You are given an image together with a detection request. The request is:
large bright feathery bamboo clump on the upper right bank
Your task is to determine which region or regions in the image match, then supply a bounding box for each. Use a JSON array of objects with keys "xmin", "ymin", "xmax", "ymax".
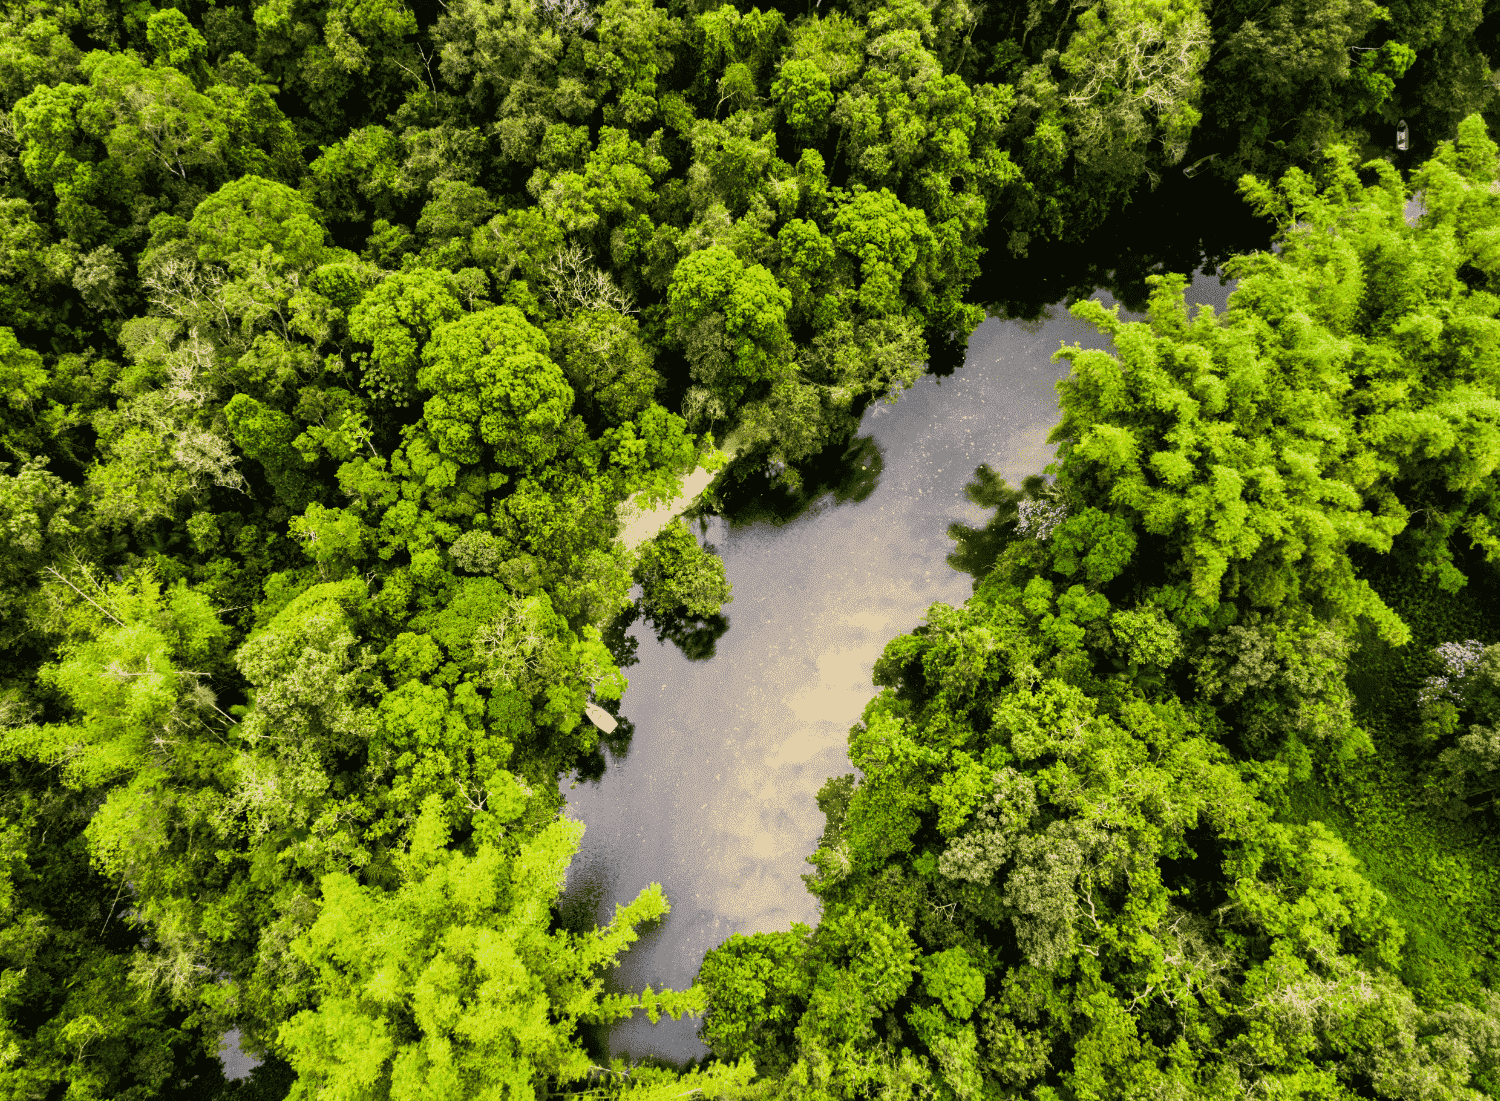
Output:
[{"xmin": 1056, "ymin": 122, "xmax": 1500, "ymax": 641}]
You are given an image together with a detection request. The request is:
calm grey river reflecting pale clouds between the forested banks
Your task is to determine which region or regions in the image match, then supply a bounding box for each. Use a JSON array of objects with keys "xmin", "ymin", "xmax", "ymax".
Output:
[{"xmin": 563, "ymin": 276, "xmax": 1230, "ymax": 1061}]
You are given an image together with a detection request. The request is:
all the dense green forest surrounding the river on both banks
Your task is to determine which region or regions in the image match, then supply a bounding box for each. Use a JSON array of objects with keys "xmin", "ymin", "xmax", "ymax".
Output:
[{"xmin": 0, "ymin": 0, "xmax": 1500, "ymax": 1101}]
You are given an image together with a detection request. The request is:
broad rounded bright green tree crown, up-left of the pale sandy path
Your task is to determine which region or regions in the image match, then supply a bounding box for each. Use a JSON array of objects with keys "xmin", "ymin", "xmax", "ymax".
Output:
[{"xmin": 417, "ymin": 306, "xmax": 573, "ymax": 468}]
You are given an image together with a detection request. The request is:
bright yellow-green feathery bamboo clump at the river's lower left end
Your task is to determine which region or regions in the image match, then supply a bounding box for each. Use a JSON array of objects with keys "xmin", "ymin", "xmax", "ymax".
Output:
[{"xmin": 281, "ymin": 792, "xmax": 714, "ymax": 1101}]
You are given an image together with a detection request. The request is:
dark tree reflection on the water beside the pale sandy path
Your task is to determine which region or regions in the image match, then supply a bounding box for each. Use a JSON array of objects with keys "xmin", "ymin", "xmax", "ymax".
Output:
[{"xmin": 713, "ymin": 437, "xmax": 885, "ymax": 528}]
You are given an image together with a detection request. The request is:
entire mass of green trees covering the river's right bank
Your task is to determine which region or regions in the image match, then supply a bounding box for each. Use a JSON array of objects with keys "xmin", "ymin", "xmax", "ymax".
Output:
[{"xmin": 701, "ymin": 119, "xmax": 1500, "ymax": 1098}]
